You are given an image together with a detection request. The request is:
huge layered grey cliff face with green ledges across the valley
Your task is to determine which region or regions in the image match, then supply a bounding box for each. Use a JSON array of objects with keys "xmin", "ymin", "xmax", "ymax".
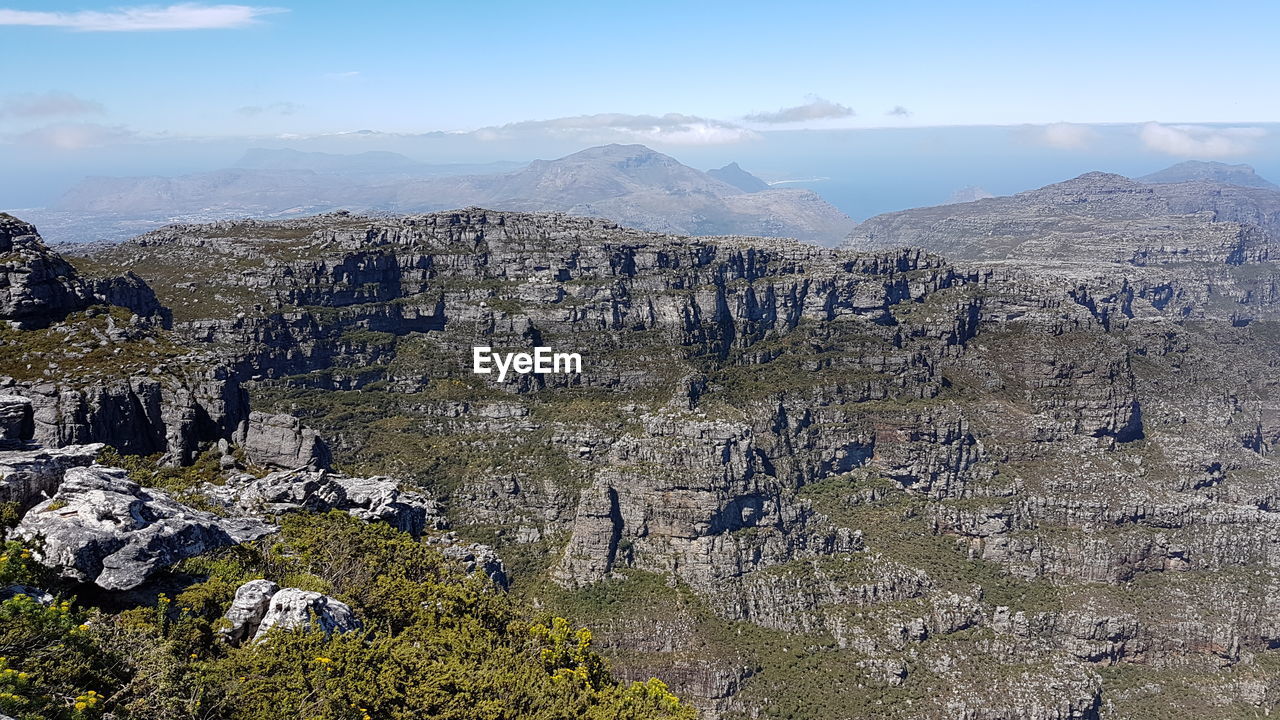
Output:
[{"xmin": 52, "ymin": 206, "xmax": 1280, "ymax": 719}]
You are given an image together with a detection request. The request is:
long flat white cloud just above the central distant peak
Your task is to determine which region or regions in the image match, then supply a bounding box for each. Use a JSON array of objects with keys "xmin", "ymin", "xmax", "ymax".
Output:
[{"xmin": 474, "ymin": 113, "xmax": 759, "ymax": 145}]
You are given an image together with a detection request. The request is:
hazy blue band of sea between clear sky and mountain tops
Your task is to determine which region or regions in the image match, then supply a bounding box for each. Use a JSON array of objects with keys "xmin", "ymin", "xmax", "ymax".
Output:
[{"xmin": 0, "ymin": 124, "xmax": 1280, "ymax": 220}]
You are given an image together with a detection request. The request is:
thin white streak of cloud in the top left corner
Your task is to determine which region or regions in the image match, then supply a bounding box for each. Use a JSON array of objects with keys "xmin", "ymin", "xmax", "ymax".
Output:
[{"xmin": 0, "ymin": 3, "xmax": 287, "ymax": 32}]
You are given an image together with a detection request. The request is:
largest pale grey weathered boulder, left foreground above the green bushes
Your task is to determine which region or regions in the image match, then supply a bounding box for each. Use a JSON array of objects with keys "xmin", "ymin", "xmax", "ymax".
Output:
[{"xmin": 13, "ymin": 465, "xmax": 275, "ymax": 591}]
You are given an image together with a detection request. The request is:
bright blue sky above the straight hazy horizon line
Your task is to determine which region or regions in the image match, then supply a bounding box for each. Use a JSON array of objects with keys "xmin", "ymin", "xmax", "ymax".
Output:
[{"xmin": 0, "ymin": 0, "xmax": 1280, "ymax": 136}]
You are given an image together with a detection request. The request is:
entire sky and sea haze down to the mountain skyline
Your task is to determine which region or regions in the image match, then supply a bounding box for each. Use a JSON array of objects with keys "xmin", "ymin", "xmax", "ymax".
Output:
[{"xmin": 0, "ymin": 3, "xmax": 1280, "ymax": 219}]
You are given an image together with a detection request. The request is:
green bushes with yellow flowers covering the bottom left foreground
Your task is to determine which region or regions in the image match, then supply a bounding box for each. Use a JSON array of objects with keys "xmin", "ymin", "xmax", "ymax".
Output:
[{"xmin": 0, "ymin": 512, "xmax": 694, "ymax": 720}]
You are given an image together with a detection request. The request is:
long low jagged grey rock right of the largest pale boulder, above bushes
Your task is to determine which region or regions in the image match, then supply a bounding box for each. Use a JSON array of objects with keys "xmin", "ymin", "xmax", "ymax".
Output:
[{"xmin": 201, "ymin": 469, "xmax": 445, "ymax": 534}]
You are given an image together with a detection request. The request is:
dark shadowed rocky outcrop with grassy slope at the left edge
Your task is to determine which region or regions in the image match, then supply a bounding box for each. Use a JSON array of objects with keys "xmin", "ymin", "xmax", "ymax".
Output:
[{"xmin": 0, "ymin": 215, "xmax": 247, "ymax": 462}]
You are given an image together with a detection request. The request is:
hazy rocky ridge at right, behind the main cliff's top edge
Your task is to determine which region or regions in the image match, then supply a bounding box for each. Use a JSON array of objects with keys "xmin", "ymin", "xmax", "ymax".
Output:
[{"xmin": 846, "ymin": 163, "xmax": 1280, "ymax": 265}]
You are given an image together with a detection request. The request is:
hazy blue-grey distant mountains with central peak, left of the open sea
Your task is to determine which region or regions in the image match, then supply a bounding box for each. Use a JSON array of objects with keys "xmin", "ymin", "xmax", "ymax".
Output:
[{"xmin": 49, "ymin": 145, "xmax": 854, "ymax": 245}]
